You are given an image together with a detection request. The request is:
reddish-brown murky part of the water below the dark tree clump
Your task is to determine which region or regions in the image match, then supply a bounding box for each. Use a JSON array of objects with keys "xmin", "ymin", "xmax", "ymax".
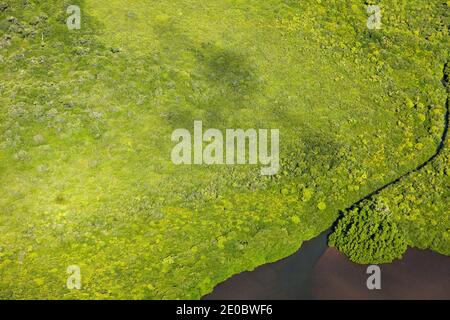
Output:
[{"xmin": 311, "ymin": 248, "xmax": 450, "ymax": 300}]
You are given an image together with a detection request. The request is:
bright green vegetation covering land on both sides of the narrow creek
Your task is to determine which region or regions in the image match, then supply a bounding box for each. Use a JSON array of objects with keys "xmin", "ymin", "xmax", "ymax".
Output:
[{"xmin": 0, "ymin": 0, "xmax": 450, "ymax": 299}]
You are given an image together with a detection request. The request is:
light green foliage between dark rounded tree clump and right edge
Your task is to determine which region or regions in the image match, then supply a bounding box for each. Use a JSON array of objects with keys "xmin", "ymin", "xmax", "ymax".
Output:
[{"xmin": 379, "ymin": 133, "xmax": 450, "ymax": 255}]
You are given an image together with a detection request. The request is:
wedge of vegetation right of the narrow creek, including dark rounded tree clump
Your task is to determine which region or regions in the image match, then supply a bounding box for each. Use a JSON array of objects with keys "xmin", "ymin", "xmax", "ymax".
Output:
[{"xmin": 329, "ymin": 64, "xmax": 450, "ymax": 264}]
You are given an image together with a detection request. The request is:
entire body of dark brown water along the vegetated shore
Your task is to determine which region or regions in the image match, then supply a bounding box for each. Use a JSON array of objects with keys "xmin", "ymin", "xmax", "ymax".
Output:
[{"xmin": 203, "ymin": 230, "xmax": 450, "ymax": 300}]
